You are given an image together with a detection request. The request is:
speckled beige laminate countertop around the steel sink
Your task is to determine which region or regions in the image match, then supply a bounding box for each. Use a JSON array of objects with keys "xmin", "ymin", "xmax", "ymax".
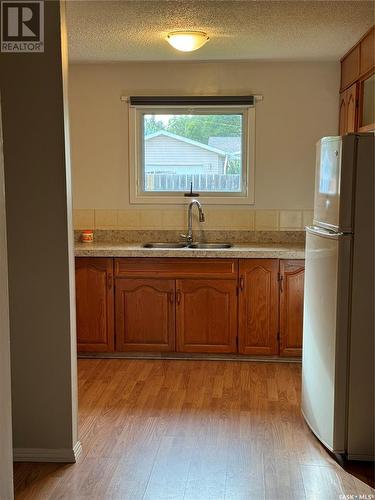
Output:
[{"xmin": 75, "ymin": 242, "xmax": 305, "ymax": 259}]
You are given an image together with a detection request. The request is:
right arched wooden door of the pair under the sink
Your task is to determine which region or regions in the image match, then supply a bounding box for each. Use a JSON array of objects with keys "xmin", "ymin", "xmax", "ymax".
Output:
[{"xmin": 176, "ymin": 279, "xmax": 237, "ymax": 353}]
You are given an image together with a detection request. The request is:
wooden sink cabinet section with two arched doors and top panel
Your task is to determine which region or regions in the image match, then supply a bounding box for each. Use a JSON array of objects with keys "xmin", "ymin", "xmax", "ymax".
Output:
[{"xmin": 115, "ymin": 258, "xmax": 238, "ymax": 353}]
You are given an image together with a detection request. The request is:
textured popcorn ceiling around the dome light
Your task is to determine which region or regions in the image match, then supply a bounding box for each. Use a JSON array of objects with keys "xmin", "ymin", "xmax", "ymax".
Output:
[{"xmin": 67, "ymin": 0, "xmax": 374, "ymax": 62}]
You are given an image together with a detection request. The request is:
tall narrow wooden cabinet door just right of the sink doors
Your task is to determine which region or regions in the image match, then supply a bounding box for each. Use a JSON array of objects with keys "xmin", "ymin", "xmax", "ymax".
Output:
[{"xmin": 238, "ymin": 259, "xmax": 279, "ymax": 356}]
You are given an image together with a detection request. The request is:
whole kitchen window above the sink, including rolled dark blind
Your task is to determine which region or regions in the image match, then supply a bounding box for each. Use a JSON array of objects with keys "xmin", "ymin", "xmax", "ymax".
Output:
[{"xmin": 129, "ymin": 96, "xmax": 255, "ymax": 204}]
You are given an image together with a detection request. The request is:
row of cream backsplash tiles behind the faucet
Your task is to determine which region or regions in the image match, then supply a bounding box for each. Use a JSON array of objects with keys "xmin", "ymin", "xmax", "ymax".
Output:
[{"xmin": 73, "ymin": 206, "xmax": 313, "ymax": 231}]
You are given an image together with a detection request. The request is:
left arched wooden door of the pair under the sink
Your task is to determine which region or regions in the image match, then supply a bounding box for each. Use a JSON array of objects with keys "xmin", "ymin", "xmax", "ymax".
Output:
[{"xmin": 115, "ymin": 278, "xmax": 175, "ymax": 352}]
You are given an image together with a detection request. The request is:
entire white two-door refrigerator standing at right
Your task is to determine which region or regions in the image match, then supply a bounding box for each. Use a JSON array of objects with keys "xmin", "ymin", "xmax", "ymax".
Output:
[{"xmin": 302, "ymin": 133, "xmax": 375, "ymax": 460}]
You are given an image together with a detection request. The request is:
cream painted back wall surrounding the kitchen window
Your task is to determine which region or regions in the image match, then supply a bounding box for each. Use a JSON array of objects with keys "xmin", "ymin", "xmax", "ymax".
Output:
[{"xmin": 69, "ymin": 62, "xmax": 339, "ymax": 230}]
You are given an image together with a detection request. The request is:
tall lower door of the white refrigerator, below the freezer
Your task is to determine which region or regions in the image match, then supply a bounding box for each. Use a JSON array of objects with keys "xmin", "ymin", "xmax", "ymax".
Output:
[{"xmin": 302, "ymin": 227, "xmax": 351, "ymax": 453}]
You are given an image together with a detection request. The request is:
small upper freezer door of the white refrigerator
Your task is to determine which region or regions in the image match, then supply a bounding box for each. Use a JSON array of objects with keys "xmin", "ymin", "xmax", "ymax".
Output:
[{"xmin": 314, "ymin": 137, "xmax": 342, "ymax": 229}]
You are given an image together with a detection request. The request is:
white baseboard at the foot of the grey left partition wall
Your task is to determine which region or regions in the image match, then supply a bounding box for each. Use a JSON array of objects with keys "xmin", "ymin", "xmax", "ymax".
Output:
[{"xmin": 13, "ymin": 441, "xmax": 82, "ymax": 463}]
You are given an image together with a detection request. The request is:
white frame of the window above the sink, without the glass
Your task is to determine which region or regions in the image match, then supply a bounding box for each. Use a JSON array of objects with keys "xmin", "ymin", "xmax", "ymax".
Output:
[{"xmin": 128, "ymin": 105, "xmax": 255, "ymax": 205}]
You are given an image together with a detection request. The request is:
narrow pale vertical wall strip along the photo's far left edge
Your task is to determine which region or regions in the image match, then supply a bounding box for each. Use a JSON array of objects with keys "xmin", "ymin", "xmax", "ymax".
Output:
[{"xmin": 0, "ymin": 97, "xmax": 13, "ymax": 500}]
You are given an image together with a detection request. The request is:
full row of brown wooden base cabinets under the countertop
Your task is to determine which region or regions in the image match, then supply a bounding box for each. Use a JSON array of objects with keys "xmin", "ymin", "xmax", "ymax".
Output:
[{"xmin": 76, "ymin": 257, "xmax": 304, "ymax": 357}]
